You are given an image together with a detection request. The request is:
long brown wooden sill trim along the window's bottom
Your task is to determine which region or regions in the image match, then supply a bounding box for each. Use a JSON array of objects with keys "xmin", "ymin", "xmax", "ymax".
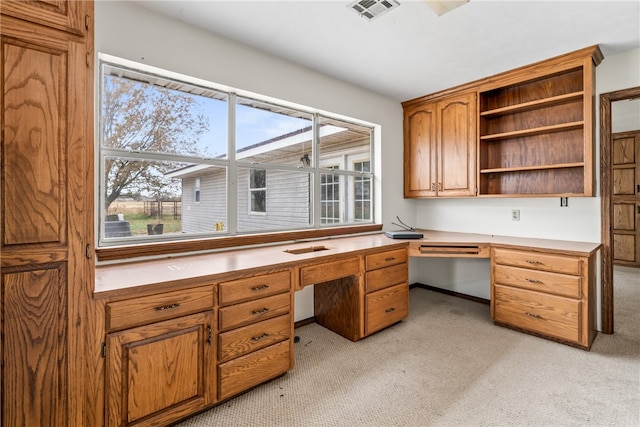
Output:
[{"xmin": 96, "ymin": 224, "xmax": 382, "ymax": 261}]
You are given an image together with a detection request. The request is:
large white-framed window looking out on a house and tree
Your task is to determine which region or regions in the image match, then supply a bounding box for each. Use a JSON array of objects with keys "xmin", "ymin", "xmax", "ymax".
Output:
[{"xmin": 97, "ymin": 55, "xmax": 373, "ymax": 251}]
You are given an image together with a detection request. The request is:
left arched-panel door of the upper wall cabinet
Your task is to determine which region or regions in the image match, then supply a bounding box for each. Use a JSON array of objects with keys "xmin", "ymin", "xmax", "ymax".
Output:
[{"xmin": 404, "ymin": 103, "xmax": 437, "ymax": 198}]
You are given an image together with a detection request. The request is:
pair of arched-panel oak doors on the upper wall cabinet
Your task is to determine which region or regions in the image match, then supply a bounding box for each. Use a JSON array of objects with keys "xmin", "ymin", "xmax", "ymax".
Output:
[{"xmin": 403, "ymin": 92, "xmax": 477, "ymax": 198}]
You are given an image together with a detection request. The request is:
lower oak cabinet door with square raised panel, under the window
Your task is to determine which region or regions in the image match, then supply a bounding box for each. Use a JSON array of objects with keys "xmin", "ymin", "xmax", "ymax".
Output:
[{"xmin": 106, "ymin": 311, "xmax": 216, "ymax": 426}]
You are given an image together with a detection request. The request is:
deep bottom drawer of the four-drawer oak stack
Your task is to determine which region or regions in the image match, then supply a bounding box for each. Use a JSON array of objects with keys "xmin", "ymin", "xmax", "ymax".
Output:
[{"xmin": 218, "ymin": 340, "xmax": 291, "ymax": 400}]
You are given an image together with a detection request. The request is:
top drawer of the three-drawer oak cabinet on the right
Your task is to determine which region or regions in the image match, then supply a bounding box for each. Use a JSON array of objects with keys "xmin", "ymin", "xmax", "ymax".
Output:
[{"xmin": 493, "ymin": 249, "xmax": 582, "ymax": 276}]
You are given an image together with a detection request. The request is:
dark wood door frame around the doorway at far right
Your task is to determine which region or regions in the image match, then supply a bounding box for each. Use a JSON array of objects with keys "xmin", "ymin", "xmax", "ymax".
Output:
[{"xmin": 600, "ymin": 86, "xmax": 640, "ymax": 334}]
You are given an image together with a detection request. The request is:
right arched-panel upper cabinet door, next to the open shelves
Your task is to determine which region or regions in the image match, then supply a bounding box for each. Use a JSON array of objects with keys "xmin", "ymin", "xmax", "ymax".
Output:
[{"xmin": 437, "ymin": 92, "xmax": 477, "ymax": 197}]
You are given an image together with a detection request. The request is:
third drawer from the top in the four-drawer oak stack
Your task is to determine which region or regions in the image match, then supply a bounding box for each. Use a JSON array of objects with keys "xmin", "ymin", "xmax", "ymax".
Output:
[{"xmin": 218, "ymin": 314, "xmax": 292, "ymax": 362}]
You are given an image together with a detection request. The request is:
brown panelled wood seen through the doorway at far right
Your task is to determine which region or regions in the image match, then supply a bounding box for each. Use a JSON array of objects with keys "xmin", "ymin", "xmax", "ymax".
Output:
[{"xmin": 611, "ymin": 131, "xmax": 640, "ymax": 267}]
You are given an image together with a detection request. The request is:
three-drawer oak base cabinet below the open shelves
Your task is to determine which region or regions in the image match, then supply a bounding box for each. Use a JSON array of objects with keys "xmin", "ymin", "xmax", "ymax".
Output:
[{"xmin": 491, "ymin": 248, "xmax": 595, "ymax": 349}]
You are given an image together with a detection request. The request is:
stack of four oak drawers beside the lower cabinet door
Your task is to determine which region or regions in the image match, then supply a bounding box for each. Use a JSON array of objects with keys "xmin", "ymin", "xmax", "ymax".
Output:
[{"xmin": 217, "ymin": 270, "xmax": 293, "ymax": 400}]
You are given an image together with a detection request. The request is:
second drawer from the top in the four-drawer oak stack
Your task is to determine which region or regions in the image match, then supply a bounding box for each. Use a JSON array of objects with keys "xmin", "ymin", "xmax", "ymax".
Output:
[{"xmin": 218, "ymin": 292, "xmax": 291, "ymax": 331}]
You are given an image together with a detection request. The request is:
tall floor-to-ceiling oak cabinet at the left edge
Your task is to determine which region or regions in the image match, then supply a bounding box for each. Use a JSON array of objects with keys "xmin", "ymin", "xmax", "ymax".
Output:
[{"xmin": 0, "ymin": 0, "xmax": 93, "ymax": 426}]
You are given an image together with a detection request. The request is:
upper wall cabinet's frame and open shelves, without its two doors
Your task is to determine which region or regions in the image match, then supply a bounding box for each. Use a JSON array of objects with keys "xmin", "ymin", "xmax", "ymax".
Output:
[{"xmin": 403, "ymin": 46, "xmax": 603, "ymax": 197}]
